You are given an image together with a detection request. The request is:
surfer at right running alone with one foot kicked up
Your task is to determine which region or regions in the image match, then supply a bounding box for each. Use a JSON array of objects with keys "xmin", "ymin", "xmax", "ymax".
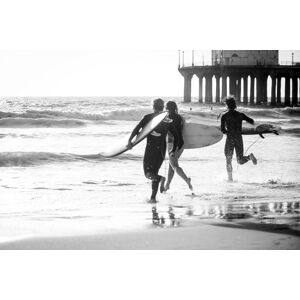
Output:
[{"xmin": 221, "ymin": 96, "xmax": 257, "ymax": 181}]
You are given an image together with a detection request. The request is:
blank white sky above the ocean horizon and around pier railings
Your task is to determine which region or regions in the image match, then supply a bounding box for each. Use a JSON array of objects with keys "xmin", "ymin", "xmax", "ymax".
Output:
[{"xmin": 0, "ymin": 49, "xmax": 300, "ymax": 96}]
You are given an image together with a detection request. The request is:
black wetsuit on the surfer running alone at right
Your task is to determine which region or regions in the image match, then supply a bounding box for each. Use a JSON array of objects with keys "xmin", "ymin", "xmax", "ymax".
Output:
[{"xmin": 221, "ymin": 110, "xmax": 254, "ymax": 166}]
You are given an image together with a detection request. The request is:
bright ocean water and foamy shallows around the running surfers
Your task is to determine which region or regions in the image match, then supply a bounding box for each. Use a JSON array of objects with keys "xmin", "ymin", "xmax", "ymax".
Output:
[{"xmin": 0, "ymin": 97, "xmax": 300, "ymax": 243}]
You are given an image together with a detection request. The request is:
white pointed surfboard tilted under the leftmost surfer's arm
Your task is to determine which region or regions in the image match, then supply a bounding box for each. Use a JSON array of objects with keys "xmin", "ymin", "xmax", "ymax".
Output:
[{"xmin": 100, "ymin": 112, "xmax": 168, "ymax": 157}]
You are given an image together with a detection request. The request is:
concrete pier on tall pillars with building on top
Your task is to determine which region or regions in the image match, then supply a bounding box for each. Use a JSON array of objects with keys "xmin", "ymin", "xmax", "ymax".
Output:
[{"xmin": 178, "ymin": 50, "xmax": 300, "ymax": 106}]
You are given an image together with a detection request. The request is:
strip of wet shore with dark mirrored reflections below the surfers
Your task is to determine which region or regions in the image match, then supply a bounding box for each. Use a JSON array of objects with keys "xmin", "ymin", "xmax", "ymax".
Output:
[{"xmin": 152, "ymin": 201, "xmax": 300, "ymax": 227}]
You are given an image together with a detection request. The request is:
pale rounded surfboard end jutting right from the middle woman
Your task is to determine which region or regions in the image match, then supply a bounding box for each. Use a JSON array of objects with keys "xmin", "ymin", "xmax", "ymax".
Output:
[{"xmin": 182, "ymin": 123, "xmax": 223, "ymax": 149}]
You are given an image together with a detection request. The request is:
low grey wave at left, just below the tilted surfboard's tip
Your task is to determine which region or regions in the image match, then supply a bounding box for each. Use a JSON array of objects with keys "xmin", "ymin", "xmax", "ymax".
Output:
[{"xmin": 0, "ymin": 152, "xmax": 141, "ymax": 167}]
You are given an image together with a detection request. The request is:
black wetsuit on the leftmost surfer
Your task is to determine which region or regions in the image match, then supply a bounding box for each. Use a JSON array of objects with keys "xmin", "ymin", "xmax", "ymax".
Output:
[{"xmin": 134, "ymin": 113, "xmax": 180, "ymax": 181}]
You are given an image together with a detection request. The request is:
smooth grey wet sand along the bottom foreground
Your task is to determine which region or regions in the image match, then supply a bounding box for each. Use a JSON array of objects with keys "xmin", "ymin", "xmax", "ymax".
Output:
[{"xmin": 0, "ymin": 220, "xmax": 300, "ymax": 250}]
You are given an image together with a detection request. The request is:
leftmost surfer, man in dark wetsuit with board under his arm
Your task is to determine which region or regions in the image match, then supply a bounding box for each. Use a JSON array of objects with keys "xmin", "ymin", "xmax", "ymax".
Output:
[{"xmin": 127, "ymin": 98, "xmax": 183, "ymax": 203}]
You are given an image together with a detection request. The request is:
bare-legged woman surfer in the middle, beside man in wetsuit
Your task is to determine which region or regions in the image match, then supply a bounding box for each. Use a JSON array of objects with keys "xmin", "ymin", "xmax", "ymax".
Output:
[{"xmin": 165, "ymin": 101, "xmax": 193, "ymax": 191}]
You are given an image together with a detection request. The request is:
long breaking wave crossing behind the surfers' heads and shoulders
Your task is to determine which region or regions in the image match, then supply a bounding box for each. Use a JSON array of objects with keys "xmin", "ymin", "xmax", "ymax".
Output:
[{"xmin": 0, "ymin": 104, "xmax": 300, "ymax": 127}]
